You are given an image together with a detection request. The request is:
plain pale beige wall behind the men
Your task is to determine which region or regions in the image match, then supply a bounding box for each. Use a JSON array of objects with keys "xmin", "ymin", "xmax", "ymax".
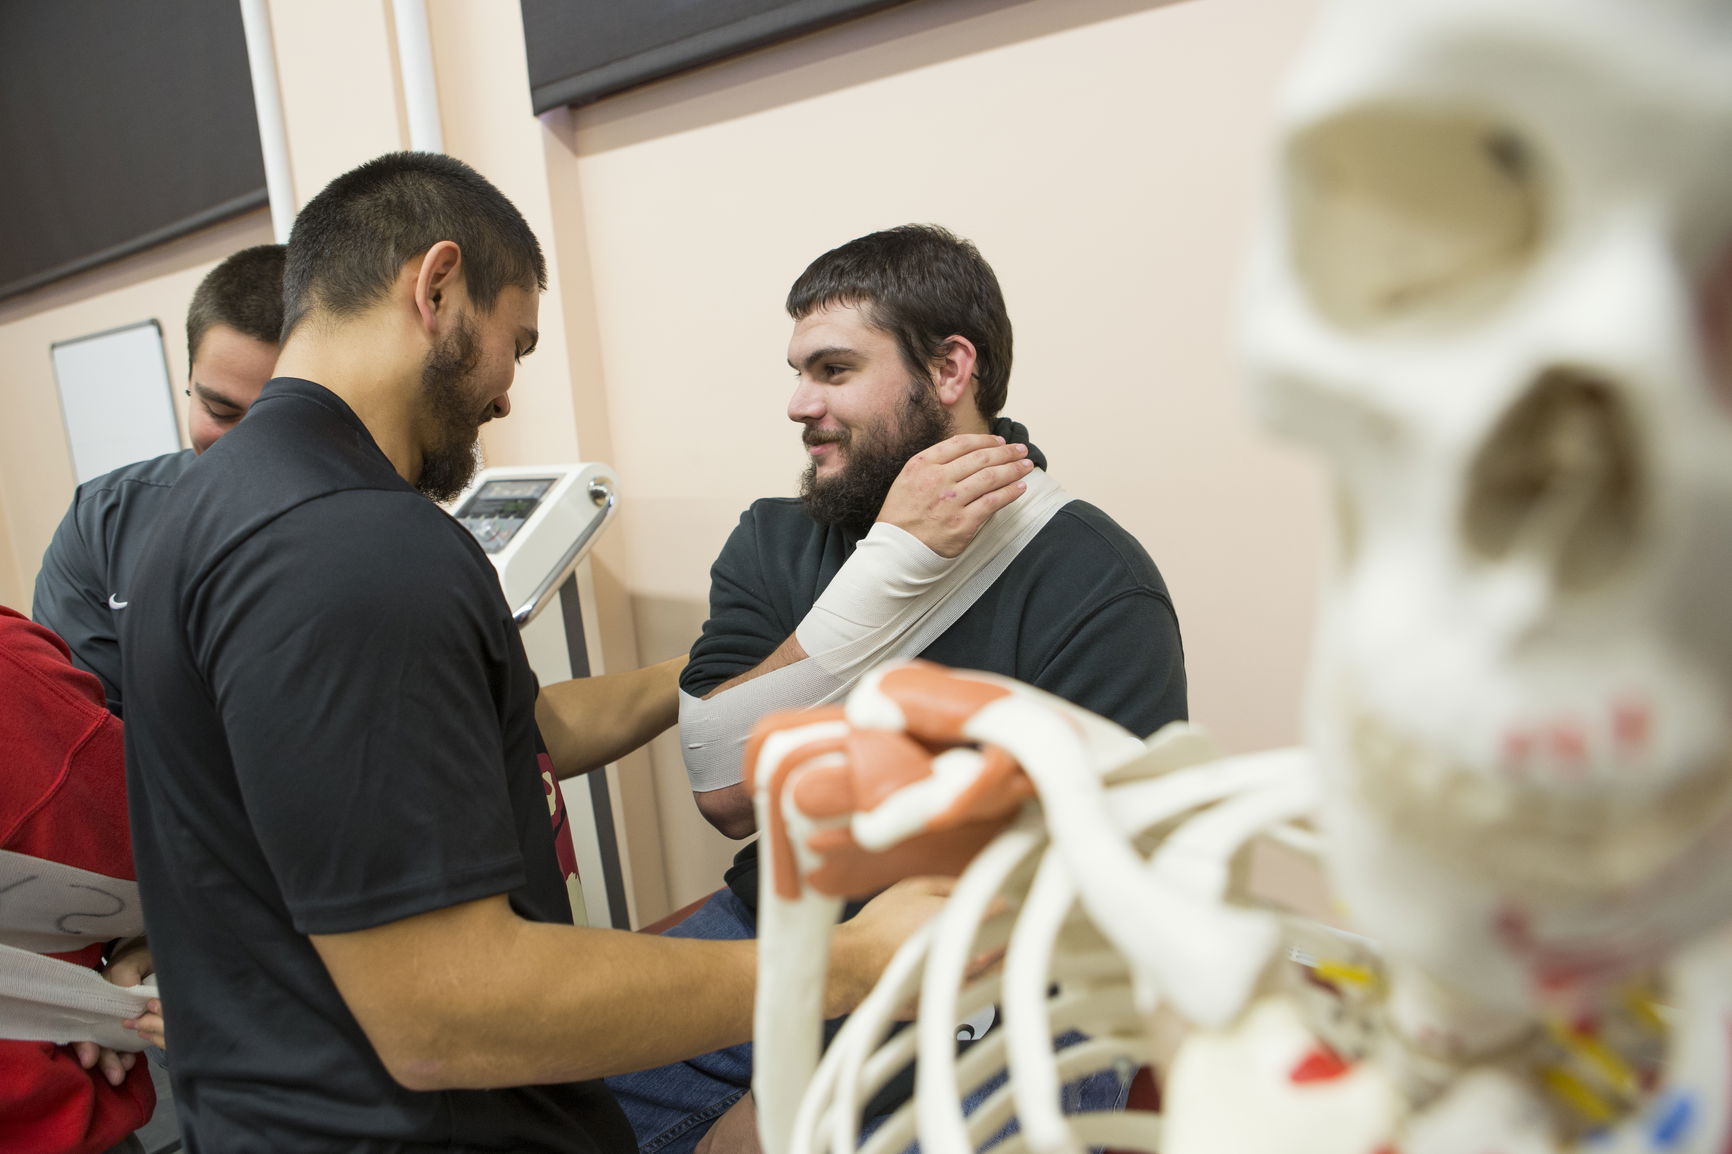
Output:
[{"xmin": 0, "ymin": 0, "xmax": 1322, "ymax": 918}]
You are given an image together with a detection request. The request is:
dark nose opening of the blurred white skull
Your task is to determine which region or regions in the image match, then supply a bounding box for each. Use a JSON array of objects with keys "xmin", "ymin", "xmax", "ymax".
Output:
[{"xmin": 1464, "ymin": 367, "xmax": 1642, "ymax": 591}]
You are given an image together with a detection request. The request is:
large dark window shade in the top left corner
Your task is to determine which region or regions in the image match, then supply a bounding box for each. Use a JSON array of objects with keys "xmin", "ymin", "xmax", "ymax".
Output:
[{"xmin": 0, "ymin": 0, "xmax": 265, "ymax": 300}]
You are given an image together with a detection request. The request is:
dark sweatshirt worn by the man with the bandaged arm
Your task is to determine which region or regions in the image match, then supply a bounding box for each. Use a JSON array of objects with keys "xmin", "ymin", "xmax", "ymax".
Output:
[{"xmin": 681, "ymin": 418, "xmax": 1186, "ymax": 908}]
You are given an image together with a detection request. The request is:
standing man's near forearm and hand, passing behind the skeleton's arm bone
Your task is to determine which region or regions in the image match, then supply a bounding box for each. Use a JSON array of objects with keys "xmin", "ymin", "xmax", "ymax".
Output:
[{"xmin": 312, "ymin": 884, "xmax": 940, "ymax": 1090}]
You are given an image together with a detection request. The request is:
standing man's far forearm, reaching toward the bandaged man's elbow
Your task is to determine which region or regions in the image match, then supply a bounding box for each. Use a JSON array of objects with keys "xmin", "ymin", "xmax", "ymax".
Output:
[{"xmin": 535, "ymin": 657, "xmax": 686, "ymax": 778}]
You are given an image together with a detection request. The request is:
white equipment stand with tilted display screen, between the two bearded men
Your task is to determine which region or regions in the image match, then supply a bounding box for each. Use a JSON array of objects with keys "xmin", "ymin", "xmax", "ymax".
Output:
[{"xmin": 450, "ymin": 463, "xmax": 630, "ymax": 929}]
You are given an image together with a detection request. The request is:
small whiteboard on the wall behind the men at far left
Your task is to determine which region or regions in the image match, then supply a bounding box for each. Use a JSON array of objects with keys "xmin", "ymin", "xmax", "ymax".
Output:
[{"xmin": 52, "ymin": 321, "xmax": 180, "ymax": 485}]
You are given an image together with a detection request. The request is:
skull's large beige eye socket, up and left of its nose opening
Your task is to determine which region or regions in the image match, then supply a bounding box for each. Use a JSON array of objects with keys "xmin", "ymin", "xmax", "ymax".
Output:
[{"xmin": 1287, "ymin": 109, "xmax": 1543, "ymax": 331}]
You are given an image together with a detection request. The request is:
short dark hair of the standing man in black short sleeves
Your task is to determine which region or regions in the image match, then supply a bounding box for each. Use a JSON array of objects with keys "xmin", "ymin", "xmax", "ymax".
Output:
[{"xmin": 282, "ymin": 152, "xmax": 547, "ymax": 336}]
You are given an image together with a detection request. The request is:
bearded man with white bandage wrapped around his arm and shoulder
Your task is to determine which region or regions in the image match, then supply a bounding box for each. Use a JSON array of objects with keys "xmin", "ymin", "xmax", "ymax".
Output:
[{"xmin": 608, "ymin": 225, "xmax": 1186, "ymax": 1154}]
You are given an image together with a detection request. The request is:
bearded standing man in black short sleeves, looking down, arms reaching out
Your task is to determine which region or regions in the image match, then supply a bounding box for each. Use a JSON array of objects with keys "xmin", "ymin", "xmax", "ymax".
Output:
[{"xmin": 121, "ymin": 152, "xmax": 939, "ymax": 1154}]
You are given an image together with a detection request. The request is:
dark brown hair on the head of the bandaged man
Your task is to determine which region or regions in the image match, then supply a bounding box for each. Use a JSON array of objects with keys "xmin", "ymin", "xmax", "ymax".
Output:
[{"xmin": 788, "ymin": 225, "xmax": 1011, "ymax": 421}]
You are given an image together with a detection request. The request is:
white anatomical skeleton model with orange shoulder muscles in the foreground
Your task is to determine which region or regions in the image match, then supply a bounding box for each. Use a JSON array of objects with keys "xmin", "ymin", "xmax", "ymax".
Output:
[{"xmin": 748, "ymin": 0, "xmax": 1732, "ymax": 1154}]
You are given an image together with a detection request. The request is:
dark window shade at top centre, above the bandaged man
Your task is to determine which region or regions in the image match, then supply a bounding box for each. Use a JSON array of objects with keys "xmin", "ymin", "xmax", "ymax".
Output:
[{"xmin": 521, "ymin": 0, "xmax": 908, "ymax": 114}]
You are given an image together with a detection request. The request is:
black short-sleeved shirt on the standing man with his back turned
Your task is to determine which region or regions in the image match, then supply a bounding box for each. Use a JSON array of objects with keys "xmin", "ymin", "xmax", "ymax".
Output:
[{"xmin": 120, "ymin": 378, "xmax": 634, "ymax": 1154}]
